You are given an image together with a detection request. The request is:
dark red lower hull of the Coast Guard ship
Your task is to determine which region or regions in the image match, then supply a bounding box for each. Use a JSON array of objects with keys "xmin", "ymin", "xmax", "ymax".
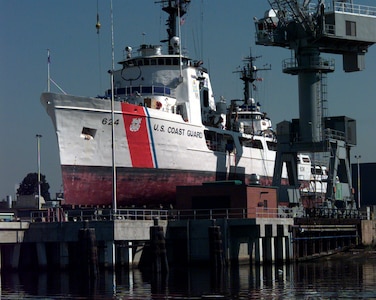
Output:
[{"xmin": 62, "ymin": 166, "xmax": 271, "ymax": 208}]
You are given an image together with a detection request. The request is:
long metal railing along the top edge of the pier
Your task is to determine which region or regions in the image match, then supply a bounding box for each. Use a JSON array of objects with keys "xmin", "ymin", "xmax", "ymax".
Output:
[{"xmin": 30, "ymin": 207, "xmax": 365, "ymax": 222}]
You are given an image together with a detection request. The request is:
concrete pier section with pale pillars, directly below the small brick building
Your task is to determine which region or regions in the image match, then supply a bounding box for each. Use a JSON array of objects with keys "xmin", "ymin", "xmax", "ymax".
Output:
[{"xmin": 166, "ymin": 218, "xmax": 293, "ymax": 264}]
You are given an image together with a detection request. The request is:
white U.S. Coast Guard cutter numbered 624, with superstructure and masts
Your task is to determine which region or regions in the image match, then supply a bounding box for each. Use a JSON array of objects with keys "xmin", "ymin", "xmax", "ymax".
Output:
[{"xmin": 41, "ymin": 0, "xmax": 310, "ymax": 207}]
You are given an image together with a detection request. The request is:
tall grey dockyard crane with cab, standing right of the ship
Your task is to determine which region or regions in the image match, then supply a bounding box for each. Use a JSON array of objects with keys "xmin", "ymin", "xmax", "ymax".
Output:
[{"xmin": 255, "ymin": 0, "xmax": 376, "ymax": 209}]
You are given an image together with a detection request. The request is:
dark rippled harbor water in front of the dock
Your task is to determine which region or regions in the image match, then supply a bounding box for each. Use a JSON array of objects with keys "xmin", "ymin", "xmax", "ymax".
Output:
[{"xmin": 1, "ymin": 252, "xmax": 376, "ymax": 299}]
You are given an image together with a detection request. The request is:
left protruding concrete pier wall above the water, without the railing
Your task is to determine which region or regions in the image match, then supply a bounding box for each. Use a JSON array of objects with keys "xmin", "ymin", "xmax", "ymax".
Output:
[{"xmin": 0, "ymin": 219, "xmax": 167, "ymax": 269}]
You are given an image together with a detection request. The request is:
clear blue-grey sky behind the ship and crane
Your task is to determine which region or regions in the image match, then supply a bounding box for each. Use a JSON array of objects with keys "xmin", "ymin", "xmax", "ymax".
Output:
[{"xmin": 0, "ymin": 0, "xmax": 376, "ymax": 200}]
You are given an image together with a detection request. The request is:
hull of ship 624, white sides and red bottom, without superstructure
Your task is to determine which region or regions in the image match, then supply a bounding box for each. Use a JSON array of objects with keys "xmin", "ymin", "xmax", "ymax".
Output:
[{"xmin": 41, "ymin": 93, "xmax": 275, "ymax": 206}]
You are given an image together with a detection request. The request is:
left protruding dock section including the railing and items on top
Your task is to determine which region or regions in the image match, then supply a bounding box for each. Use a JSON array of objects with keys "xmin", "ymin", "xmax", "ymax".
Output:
[{"xmin": 0, "ymin": 209, "xmax": 167, "ymax": 269}]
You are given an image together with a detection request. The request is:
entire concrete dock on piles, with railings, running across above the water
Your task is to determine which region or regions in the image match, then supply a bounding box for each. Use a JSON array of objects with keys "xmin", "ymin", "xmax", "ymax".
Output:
[{"xmin": 0, "ymin": 208, "xmax": 372, "ymax": 270}]
